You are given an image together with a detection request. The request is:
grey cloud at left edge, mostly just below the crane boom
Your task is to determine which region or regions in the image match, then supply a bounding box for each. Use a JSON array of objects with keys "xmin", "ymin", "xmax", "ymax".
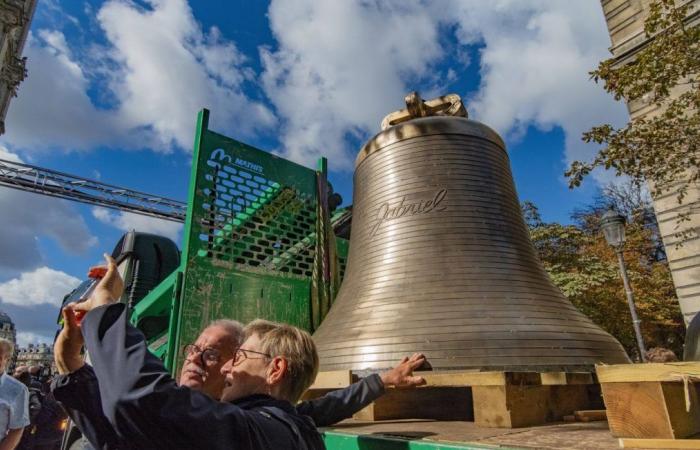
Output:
[{"xmin": 0, "ymin": 146, "xmax": 97, "ymax": 273}]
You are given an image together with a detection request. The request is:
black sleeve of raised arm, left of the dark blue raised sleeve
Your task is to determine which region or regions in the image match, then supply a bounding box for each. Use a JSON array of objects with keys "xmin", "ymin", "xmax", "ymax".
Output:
[{"xmin": 51, "ymin": 364, "xmax": 119, "ymax": 450}]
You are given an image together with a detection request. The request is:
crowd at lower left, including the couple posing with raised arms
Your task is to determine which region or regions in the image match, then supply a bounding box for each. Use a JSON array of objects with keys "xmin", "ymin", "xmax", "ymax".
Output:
[{"xmin": 0, "ymin": 255, "xmax": 426, "ymax": 450}]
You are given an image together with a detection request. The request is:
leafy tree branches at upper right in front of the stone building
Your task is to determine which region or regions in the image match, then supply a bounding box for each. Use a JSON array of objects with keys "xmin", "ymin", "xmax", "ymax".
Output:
[{"xmin": 566, "ymin": 0, "xmax": 700, "ymax": 213}]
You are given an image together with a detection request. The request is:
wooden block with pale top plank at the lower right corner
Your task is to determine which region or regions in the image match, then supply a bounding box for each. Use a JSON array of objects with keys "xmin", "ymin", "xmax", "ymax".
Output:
[{"xmin": 596, "ymin": 362, "xmax": 700, "ymax": 440}]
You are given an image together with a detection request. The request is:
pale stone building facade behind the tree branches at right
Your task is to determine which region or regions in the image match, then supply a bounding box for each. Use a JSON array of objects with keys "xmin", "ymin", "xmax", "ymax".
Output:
[{"xmin": 601, "ymin": 0, "xmax": 700, "ymax": 324}]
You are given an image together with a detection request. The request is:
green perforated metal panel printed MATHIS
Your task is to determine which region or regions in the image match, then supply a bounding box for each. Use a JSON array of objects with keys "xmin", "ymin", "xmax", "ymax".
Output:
[{"xmin": 169, "ymin": 110, "xmax": 318, "ymax": 370}]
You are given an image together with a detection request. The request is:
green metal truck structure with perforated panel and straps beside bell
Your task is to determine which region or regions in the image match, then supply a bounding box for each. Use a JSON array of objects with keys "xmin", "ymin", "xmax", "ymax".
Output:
[{"xmin": 131, "ymin": 110, "xmax": 348, "ymax": 373}]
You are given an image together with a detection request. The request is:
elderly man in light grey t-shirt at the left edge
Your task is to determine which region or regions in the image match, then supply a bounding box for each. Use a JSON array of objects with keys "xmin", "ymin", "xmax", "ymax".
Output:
[{"xmin": 0, "ymin": 338, "xmax": 29, "ymax": 450}]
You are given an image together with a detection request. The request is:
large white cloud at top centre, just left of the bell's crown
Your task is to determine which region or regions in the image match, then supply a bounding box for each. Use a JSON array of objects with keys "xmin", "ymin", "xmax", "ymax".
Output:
[{"xmin": 261, "ymin": 0, "xmax": 443, "ymax": 169}]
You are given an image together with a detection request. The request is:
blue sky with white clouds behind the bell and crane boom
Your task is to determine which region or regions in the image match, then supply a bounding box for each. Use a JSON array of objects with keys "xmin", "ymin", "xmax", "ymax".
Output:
[{"xmin": 0, "ymin": 0, "xmax": 626, "ymax": 344}]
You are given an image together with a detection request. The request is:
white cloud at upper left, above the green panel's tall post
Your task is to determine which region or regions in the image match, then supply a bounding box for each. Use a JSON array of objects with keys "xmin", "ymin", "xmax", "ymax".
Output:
[{"xmin": 98, "ymin": 0, "xmax": 274, "ymax": 149}]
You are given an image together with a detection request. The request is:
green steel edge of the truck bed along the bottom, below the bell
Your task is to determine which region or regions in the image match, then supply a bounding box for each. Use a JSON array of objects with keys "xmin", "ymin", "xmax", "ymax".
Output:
[{"xmin": 323, "ymin": 431, "xmax": 516, "ymax": 450}]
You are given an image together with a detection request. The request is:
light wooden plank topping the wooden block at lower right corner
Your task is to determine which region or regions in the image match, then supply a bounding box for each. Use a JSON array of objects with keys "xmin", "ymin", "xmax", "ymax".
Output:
[{"xmin": 595, "ymin": 362, "xmax": 700, "ymax": 383}]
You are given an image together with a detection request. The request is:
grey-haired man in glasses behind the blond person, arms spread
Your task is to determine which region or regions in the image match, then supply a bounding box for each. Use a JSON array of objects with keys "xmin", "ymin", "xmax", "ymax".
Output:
[{"xmin": 53, "ymin": 256, "xmax": 425, "ymax": 449}]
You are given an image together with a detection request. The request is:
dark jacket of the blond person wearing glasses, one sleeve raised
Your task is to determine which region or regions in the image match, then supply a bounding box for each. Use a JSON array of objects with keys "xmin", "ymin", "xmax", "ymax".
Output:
[{"xmin": 60, "ymin": 304, "xmax": 325, "ymax": 450}]
